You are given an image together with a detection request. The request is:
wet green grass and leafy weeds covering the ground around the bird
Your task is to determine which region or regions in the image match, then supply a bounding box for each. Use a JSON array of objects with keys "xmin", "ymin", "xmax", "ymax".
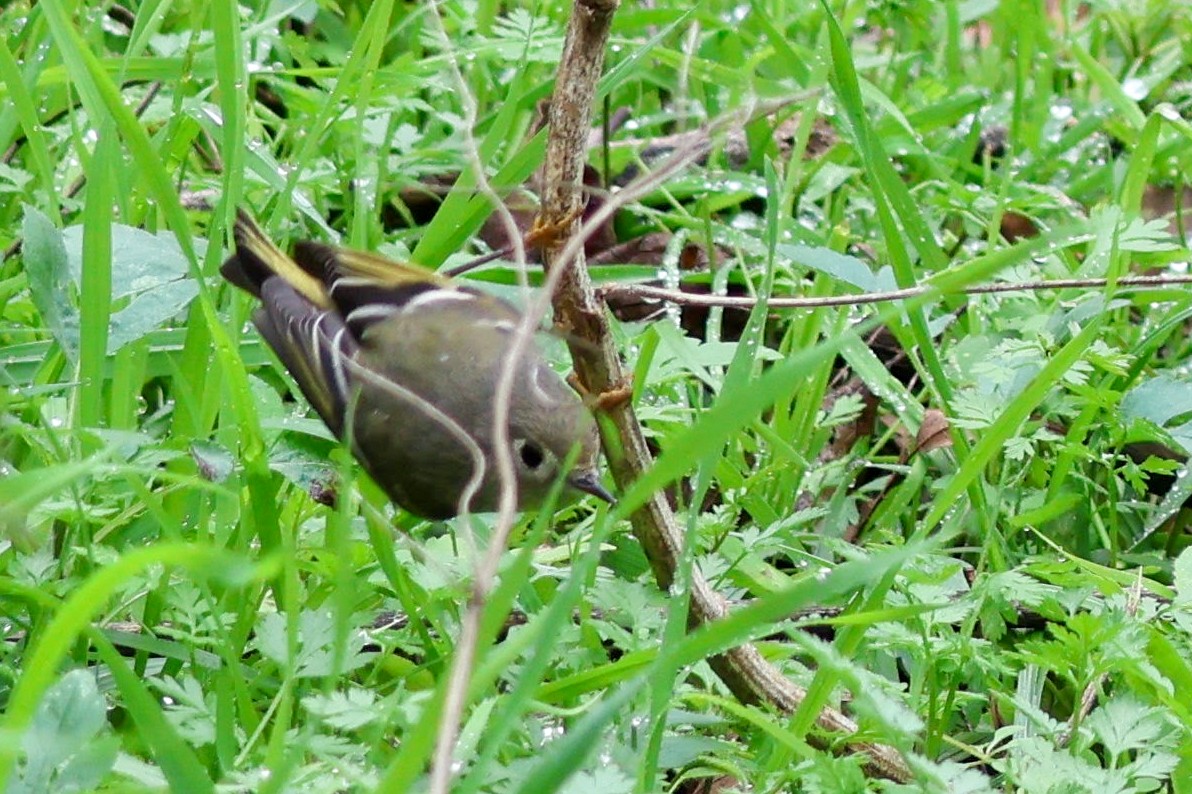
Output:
[{"xmin": 0, "ymin": 0, "xmax": 1192, "ymax": 794}]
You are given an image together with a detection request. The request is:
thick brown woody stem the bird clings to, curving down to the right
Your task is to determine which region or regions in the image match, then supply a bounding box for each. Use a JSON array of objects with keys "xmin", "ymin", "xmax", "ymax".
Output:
[{"xmin": 538, "ymin": 0, "xmax": 909, "ymax": 781}]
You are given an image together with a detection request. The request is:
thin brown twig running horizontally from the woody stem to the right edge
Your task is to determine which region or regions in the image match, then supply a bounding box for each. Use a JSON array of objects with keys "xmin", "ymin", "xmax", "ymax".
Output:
[{"xmin": 600, "ymin": 275, "xmax": 1192, "ymax": 309}]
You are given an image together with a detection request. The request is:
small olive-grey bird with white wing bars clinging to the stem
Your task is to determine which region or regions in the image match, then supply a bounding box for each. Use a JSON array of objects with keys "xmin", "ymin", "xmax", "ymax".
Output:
[{"xmin": 221, "ymin": 211, "xmax": 613, "ymax": 519}]
